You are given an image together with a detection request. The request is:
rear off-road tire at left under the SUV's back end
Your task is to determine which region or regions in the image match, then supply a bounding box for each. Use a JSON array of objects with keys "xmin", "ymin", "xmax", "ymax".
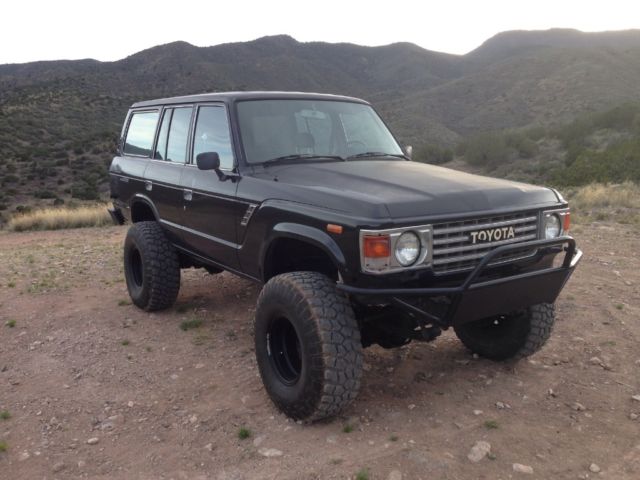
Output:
[{"xmin": 124, "ymin": 222, "xmax": 180, "ymax": 312}]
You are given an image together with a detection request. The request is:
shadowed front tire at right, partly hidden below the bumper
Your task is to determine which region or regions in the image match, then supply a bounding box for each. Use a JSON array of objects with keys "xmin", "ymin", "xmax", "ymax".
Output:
[{"xmin": 454, "ymin": 303, "xmax": 555, "ymax": 360}]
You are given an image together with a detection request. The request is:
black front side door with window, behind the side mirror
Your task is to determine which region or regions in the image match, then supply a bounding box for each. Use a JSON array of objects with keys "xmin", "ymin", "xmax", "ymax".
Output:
[{"xmin": 182, "ymin": 104, "xmax": 241, "ymax": 269}]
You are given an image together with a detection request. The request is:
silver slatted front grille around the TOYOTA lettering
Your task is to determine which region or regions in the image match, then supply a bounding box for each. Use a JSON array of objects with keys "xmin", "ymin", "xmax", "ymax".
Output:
[{"xmin": 433, "ymin": 211, "xmax": 538, "ymax": 273}]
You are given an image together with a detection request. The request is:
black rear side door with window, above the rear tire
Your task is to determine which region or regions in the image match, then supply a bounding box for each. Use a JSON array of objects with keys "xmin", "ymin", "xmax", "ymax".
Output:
[{"xmin": 145, "ymin": 105, "xmax": 193, "ymax": 242}]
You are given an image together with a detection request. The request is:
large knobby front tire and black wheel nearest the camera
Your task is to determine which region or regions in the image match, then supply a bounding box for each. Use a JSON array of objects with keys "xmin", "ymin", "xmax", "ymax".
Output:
[{"xmin": 255, "ymin": 272, "xmax": 362, "ymax": 422}]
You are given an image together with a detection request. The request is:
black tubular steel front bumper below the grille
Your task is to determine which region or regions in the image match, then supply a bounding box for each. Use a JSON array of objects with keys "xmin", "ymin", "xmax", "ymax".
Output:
[{"xmin": 338, "ymin": 237, "xmax": 582, "ymax": 328}]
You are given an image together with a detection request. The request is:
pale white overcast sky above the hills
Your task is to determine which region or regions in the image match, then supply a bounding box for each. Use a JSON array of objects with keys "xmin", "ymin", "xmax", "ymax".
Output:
[{"xmin": 0, "ymin": 0, "xmax": 640, "ymax": 64}]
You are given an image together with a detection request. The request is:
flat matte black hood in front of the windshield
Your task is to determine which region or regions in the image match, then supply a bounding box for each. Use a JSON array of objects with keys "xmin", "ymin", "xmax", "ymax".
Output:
[{"xmin": 250, "ymin": 160, "xmax": 558, "ymax": 219}]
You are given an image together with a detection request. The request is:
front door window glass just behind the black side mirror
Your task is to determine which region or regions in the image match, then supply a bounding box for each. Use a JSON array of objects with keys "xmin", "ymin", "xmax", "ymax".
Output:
[{"xmin": 193, "ymin": 106, "xmax": 238, "ymax": 170}]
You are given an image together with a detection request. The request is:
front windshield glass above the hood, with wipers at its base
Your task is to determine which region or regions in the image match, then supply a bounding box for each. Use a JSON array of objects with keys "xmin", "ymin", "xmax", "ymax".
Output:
[{"xmin": 238, "ymin": 100, "xmax": 402, "ymax": 163}]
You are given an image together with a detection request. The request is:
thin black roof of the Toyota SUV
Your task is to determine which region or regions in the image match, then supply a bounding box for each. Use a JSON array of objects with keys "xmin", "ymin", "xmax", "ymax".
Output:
[{"xmin": 131, "ymin": 91, "xmax": 368, "ymax": 108}]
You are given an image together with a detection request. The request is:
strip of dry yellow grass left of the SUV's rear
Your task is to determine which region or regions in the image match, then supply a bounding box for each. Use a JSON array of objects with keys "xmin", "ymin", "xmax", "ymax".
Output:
[{"xmin": 6, "ymin": 204, "xmax": 112, "ymax": 232}]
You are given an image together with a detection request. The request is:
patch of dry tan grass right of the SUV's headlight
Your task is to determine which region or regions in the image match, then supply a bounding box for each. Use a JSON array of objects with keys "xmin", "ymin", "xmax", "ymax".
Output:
[{"xmin": 563, "ymin": 182, "xmax": 640, "ymax": 224}]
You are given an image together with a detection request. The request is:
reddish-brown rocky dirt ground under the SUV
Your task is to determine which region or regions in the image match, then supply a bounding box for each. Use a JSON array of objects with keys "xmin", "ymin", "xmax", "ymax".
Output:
[{"xmin": 0, "ymin": 224, "xmax": 640, "ymax": 480}]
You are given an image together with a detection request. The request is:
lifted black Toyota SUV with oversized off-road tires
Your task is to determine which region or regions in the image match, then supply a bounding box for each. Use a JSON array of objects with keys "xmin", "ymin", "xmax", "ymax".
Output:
[{"xmin": 110, "ymin": 92, "xmax": 581, "ymax": 420}]
